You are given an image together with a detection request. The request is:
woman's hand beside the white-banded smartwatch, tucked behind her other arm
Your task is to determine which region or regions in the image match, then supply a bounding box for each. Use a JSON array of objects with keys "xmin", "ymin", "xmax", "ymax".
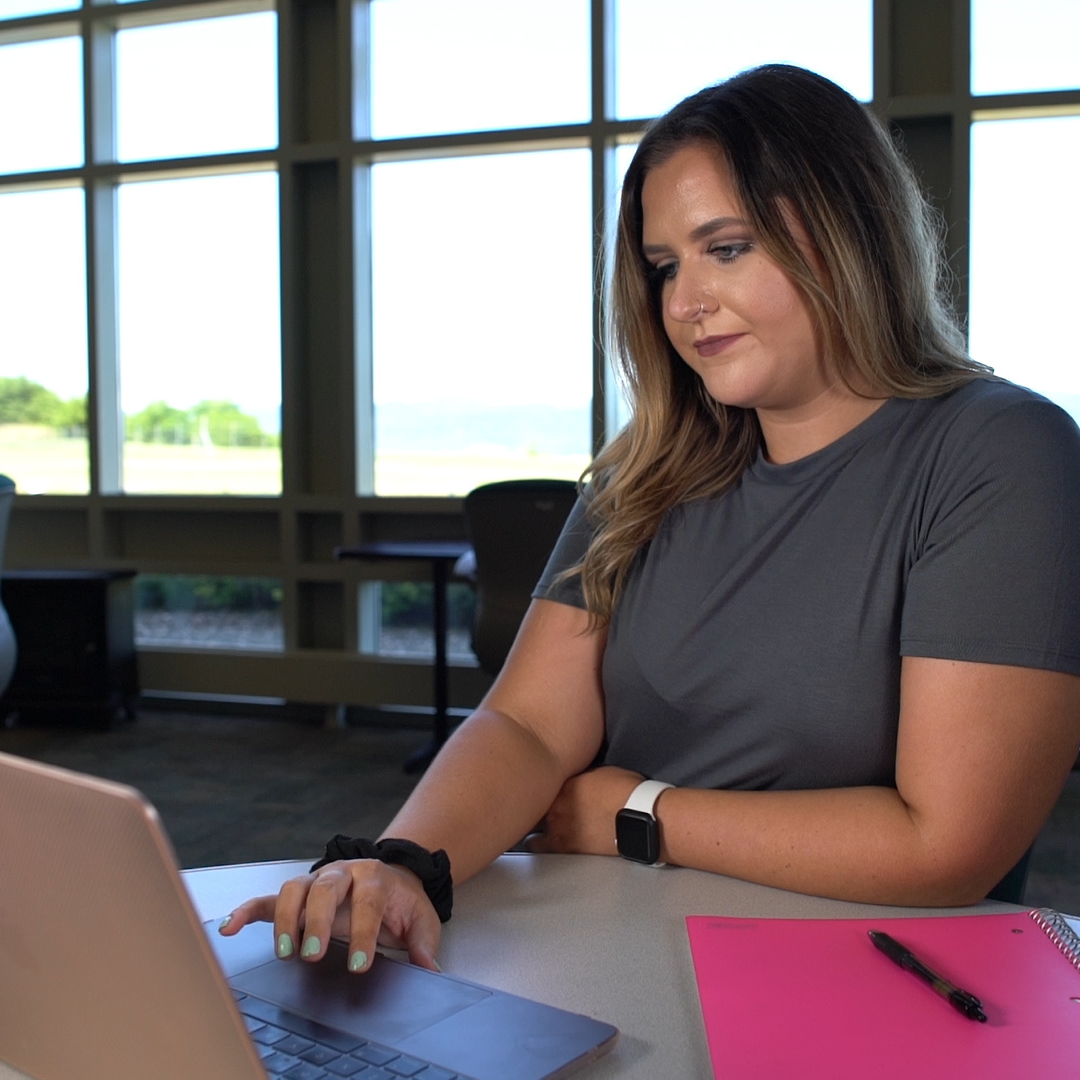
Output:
[{"xmin": 529, "ymin": 765, "xmax": 645, "ymax": 855}]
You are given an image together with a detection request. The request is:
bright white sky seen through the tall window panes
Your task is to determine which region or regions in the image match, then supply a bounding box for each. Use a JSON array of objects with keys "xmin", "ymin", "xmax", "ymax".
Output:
[{"xmin": 0, "ymin": 0, "xmax": 1080, "ymax": 422}]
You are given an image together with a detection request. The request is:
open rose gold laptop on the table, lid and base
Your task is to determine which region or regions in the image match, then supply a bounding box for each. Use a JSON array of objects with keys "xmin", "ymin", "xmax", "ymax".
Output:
[{"xmin": 0, "ymin": 754, "xmax": 617, "ymax": 1080}]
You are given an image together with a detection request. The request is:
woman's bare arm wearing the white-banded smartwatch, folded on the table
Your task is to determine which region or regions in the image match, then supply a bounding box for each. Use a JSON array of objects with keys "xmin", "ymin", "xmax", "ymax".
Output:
[{"xmin": 539, "ymin": 657, "xmax": 1080, "ymax": 905}]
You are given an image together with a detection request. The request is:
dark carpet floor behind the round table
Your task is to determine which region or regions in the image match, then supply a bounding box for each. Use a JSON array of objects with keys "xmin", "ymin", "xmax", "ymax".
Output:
[{"xmin": 0, "ymin": 710, "xmax": 1080, "ymax": 915}]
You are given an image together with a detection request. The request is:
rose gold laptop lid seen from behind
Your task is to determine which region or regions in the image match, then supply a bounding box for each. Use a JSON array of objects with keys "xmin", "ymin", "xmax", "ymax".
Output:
[{"xmin": 0, "ymin": 754, "xmax": 266, "ymax": 1080}]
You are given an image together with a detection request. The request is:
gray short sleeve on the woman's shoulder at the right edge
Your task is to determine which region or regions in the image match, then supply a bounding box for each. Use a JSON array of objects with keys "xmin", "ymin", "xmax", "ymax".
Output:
[{"xmin": 901, "ymin": 388, "xmax": 1080, "ymax": 674}]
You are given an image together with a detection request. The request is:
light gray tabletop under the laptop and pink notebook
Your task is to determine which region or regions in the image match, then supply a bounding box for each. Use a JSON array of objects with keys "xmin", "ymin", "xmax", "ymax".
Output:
[{"xmin": 8, "ymin": 854, "xmax": 1067, "ymax": 1080}]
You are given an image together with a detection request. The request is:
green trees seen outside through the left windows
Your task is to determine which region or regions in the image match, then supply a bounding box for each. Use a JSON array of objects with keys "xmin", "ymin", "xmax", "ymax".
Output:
[{"xmin": 0, "ymin": 376, "xmax": 279, "ymax": 446}]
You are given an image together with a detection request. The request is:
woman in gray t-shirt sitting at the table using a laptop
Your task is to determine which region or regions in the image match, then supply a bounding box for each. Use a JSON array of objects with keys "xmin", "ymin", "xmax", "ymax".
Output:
[{"xmin": 222, "ymin": 66, "xmax": 1080, "ymax": 971}]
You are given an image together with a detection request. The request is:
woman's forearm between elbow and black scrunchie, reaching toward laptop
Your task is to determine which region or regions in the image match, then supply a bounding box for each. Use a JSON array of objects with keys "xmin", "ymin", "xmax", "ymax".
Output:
[{"xmin": 383, "ymin": 706, "xmax": 567, "ymax": 883}]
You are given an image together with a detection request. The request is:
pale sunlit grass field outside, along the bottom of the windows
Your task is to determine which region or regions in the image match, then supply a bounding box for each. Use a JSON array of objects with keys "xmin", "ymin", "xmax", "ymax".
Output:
[{"xmin": 0, "ymin": 424, "xmax": 589, "ymax": 496}]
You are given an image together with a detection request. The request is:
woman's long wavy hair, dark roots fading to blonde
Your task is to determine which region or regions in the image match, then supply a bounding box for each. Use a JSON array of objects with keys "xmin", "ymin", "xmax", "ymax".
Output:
[{"xmin": 567, "ymin": 65, "xmax": 991, "ymax": 624}]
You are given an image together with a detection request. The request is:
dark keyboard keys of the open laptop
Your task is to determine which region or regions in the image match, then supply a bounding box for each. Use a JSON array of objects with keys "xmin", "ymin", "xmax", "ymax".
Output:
[{"xmin": 232, "ymin": 990, "xmax": 468, "ymax": 1080}]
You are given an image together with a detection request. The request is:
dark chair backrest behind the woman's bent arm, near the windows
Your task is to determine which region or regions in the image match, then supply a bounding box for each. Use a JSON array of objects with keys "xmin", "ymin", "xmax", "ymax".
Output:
[{"xmin": 464, "ymin": 480, "xmax": 578, "ymax": 675}]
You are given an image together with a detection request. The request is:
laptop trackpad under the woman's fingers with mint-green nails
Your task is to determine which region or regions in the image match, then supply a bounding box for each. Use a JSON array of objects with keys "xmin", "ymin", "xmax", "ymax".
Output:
[{"xmin": 236, "ymin": 942, "xmax": 491, "ymax": 1042}]
